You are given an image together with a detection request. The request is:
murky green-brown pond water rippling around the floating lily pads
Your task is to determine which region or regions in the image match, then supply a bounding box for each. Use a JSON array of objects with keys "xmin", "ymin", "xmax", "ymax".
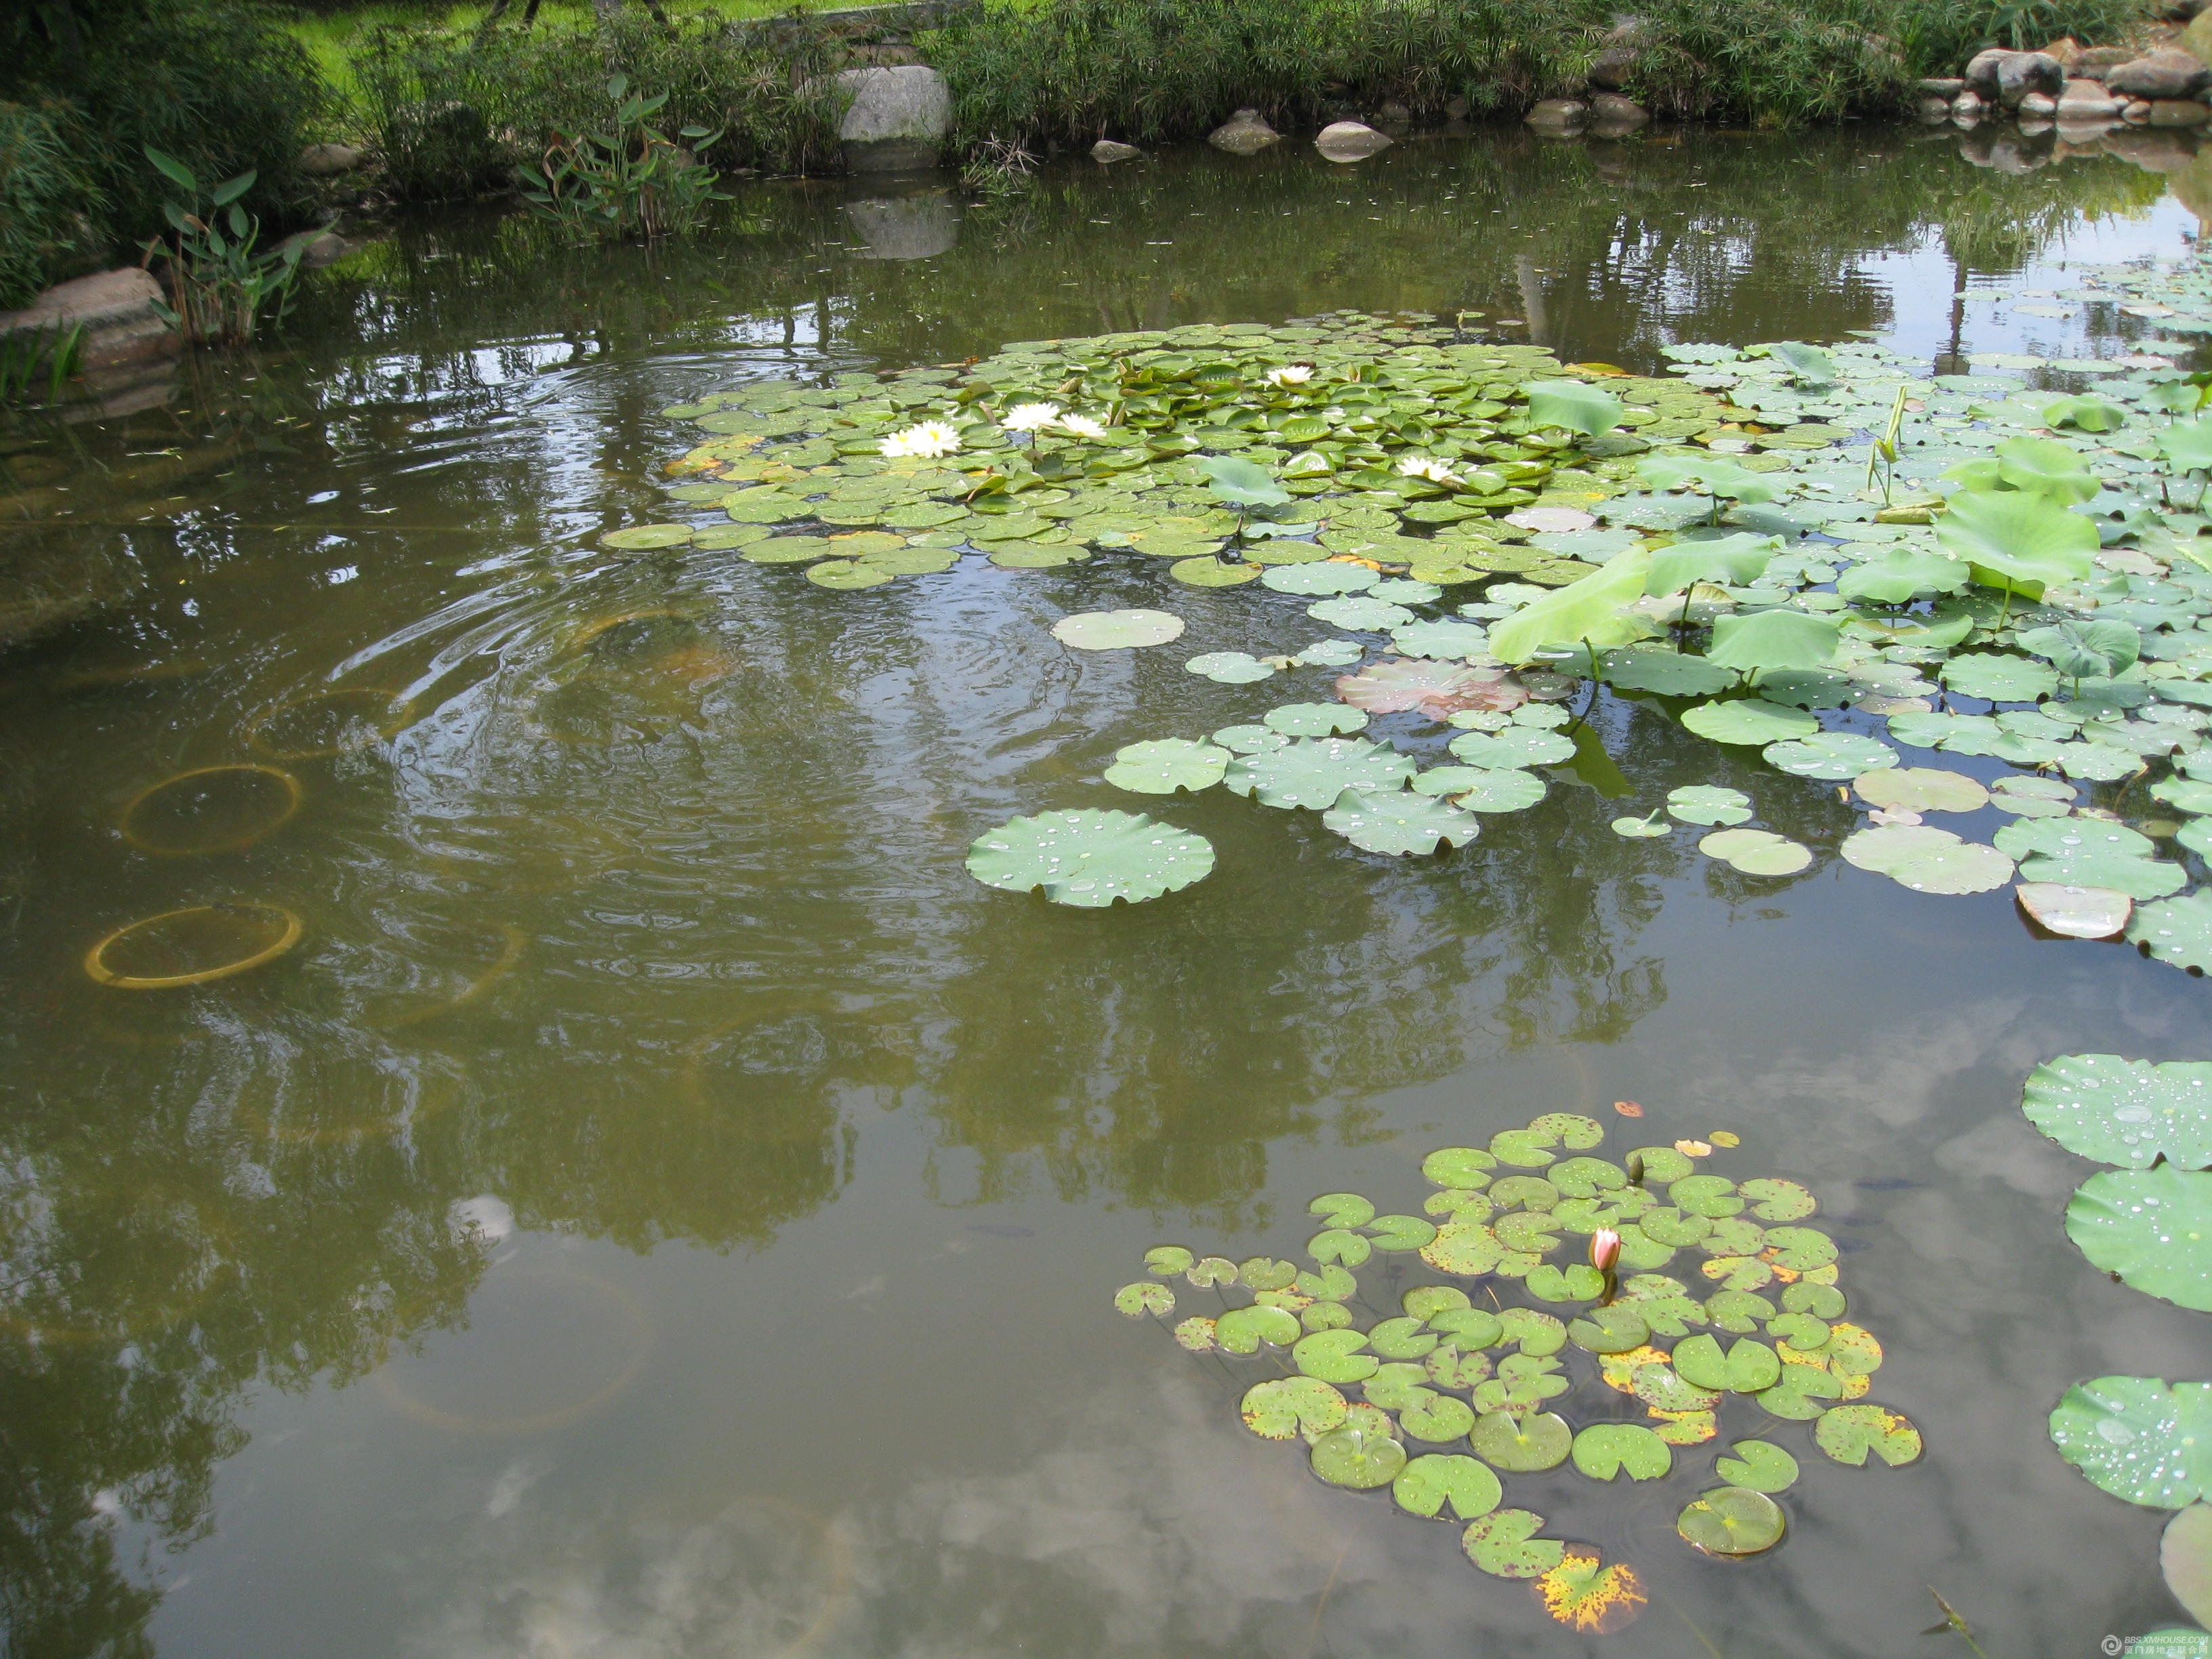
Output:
[{"xmin": 0, "ymin": 131, "xmax": 2205, "ymax": 1659}]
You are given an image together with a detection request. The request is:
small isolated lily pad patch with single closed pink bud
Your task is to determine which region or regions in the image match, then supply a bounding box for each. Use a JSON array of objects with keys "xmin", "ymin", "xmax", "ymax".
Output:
[{"xmin": 1115, "ymin": 1113, "xmax": 1922, "ymax": 1631}]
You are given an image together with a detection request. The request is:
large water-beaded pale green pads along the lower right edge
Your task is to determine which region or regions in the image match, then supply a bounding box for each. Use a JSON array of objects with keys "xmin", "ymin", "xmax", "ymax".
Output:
[{"xmin": 2022, "ymin": 1055, "xmax": 2212, "ymax": 1624}]
